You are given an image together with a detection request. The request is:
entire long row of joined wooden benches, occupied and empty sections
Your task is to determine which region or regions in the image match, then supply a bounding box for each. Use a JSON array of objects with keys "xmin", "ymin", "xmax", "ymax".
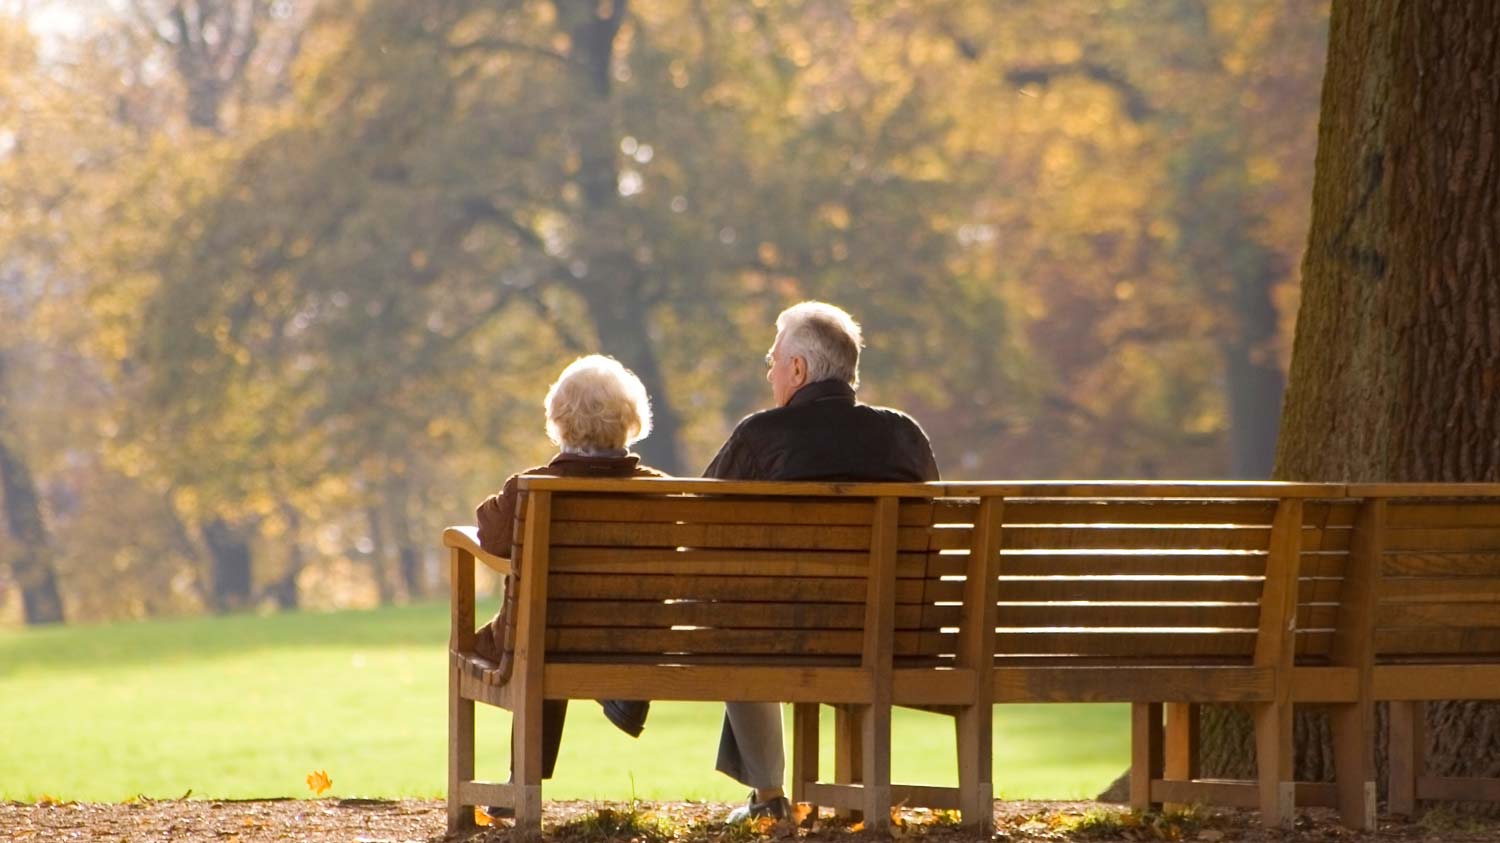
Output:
[{"xmin": 446, "ymin": 477, "xmax": 1500, "ymax": 836}]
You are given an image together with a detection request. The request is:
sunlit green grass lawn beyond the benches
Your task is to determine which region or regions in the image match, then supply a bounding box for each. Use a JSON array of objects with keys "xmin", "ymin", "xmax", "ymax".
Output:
[{"xmin": 0, "ymin": 603, "xmax": 1130, "ymax": 801}]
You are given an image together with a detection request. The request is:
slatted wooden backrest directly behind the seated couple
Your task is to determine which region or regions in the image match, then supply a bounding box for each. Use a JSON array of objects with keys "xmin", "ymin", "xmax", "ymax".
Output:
[{"xmin": 518, "ymin": 480, "xmax": 932, "ymax": 666}]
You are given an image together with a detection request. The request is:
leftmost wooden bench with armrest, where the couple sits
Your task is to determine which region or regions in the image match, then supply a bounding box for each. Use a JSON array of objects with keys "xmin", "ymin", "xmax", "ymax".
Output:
[{"xmin": 444, "ymin": 477, "xmax": 989, "ymax": 837}]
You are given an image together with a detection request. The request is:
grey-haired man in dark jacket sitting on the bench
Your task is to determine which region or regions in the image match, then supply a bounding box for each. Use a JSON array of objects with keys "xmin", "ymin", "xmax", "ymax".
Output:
[{"xmin": 704, "ymin": 302, "xmax": 938, "ymax": 822}]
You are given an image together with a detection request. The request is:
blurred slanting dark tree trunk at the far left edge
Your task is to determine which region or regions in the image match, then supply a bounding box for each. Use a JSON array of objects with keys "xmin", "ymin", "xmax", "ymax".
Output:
[{"xmin": 0, "ymin": 351, "xmax": 63, "ymax": 626}]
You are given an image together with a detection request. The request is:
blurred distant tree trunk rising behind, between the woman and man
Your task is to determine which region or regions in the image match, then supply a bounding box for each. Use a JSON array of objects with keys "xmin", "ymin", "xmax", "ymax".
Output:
[{"xmin": 554, "ymin": 0, "xmax": 683, "ymax": 474}]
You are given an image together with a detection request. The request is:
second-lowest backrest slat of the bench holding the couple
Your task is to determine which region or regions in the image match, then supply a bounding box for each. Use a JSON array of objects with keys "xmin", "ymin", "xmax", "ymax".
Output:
[{"xmin": 548, "ymin": 600, "xmax": 962, "ymax": 635}]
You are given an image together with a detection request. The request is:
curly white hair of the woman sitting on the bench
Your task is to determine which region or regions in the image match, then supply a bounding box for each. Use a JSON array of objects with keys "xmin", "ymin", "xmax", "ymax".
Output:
[{"xmin": 545, "ymin": 354, "xmax": 651, "ymax": 452}]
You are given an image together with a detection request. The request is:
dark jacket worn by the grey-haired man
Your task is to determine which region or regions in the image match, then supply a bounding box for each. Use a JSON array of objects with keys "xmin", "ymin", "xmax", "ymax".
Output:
[{"xmin": 704, "ymin": 380, "xmax": 938, "ymax": 483}]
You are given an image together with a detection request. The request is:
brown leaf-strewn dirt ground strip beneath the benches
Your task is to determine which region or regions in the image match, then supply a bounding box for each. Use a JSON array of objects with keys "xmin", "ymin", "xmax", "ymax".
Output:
[{"xmin": 0, "ymin": 800, "xmax": 1500, "ymax": 843}]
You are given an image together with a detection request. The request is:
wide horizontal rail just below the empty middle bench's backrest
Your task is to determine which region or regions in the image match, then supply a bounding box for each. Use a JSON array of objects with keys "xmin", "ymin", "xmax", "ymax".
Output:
[{"xmin": 993, "ymin": 666, "xmax": 1275, "ymax": 702}]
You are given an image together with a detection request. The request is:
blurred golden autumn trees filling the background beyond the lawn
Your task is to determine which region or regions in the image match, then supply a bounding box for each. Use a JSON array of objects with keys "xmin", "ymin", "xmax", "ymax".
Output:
[{"xmin": 0, "ymin": 0, "xmax": 1328, "ymax": 623}]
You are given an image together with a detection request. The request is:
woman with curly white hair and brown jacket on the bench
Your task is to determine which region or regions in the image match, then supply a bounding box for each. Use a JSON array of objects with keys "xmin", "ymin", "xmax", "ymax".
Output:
[{"xmin": 474, "ymin": 354, "xmax": 663, "ymax": 779}]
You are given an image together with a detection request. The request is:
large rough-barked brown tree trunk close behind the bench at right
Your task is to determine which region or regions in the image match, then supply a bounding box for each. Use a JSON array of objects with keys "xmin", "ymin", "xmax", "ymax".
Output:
[{"xmin": 1205, "ymin": 0, "xmax": 1500, "ymax": 798}]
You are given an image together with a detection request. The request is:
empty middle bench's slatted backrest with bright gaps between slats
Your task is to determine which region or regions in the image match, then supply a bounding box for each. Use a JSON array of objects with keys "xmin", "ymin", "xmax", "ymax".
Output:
[{"xmin": 972, "ymin": 492, "xmax": 1298, "ymax": 665}]
